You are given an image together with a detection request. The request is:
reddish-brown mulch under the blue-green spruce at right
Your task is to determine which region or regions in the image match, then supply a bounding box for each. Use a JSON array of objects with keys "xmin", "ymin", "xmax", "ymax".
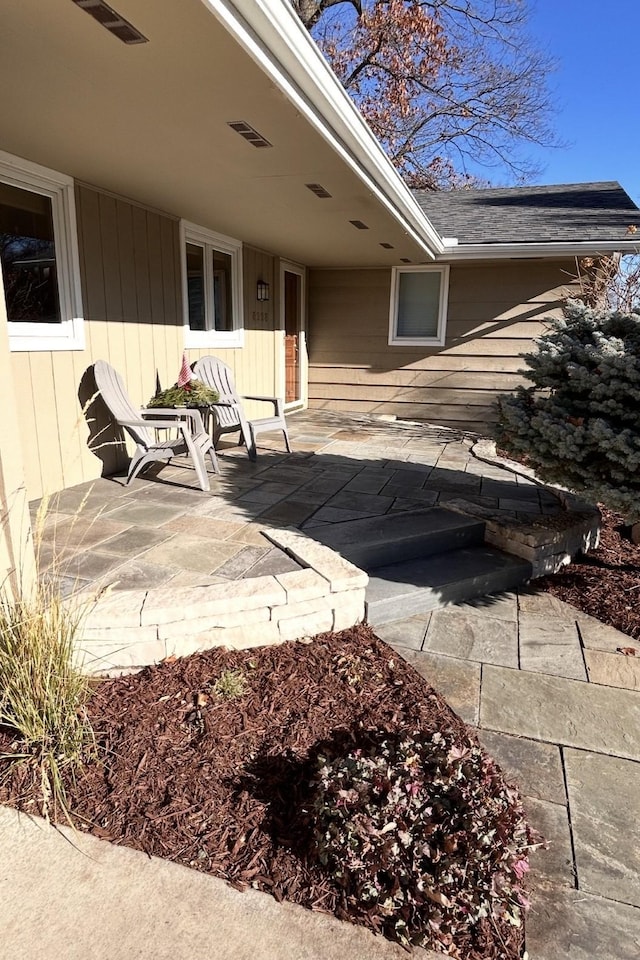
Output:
[{"xmin": 535, "ymin": 505, "xmax": 640, "ymax": 640}]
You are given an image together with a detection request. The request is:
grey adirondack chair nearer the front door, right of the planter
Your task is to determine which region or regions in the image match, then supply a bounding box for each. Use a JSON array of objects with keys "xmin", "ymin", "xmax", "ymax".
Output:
[{"xmin": 193, "ymin": 357, "xmax": 291, "ymax": 460}]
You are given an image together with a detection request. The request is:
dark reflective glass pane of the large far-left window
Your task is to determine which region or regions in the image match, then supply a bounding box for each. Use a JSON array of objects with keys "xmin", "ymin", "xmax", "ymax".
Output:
[{"xmin": 0, "ymin": 183, "xmax": 62, "ymax": 323}]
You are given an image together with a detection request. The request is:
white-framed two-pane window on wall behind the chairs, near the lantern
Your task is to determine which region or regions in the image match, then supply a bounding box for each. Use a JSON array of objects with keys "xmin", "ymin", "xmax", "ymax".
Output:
[{"xmin": 182, "ymin": 222, "xmax": 243, "ymax": 347}]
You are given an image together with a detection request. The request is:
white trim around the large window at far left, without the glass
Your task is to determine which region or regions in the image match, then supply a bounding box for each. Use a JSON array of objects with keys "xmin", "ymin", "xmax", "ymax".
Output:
[{"xmin": 0, "ymin": 150, "xmax": 85, "ymax": 352}]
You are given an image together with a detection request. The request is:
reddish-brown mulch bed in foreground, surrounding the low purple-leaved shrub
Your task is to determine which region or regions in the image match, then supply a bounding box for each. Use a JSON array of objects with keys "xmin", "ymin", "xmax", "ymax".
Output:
[{"xmin": 0, "ymin": 626, "xmax": 522, "ymax": 960}]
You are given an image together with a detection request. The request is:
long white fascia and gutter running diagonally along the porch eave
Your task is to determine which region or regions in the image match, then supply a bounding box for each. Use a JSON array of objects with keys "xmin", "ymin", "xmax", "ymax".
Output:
[{"xmin": 201, "ymin": 0, "xmax": 444, "ymax": 260}]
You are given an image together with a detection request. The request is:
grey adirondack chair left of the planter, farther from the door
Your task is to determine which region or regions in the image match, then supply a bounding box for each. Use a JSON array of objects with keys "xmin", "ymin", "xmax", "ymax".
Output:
[{"xmin": 93, "ymin": 360, "xmax": 220, "ymax": 490}]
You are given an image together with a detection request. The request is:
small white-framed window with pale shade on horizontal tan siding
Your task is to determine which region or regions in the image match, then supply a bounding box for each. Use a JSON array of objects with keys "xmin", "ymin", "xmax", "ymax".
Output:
[{"xmin": 389, "ymin": 266, "xmax": 449, "ymax": 346}]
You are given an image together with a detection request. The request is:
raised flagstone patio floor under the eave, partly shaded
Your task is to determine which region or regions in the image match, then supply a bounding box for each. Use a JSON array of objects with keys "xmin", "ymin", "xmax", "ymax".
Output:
[{"xmin": 32, "ymin": 411, "xmax": 592, "ymax": 594}]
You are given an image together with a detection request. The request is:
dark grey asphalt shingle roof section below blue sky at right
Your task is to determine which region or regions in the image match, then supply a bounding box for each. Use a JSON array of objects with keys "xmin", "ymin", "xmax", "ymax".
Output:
[{"xmin": 414, "ymin": 181, "xmax": 640, "ymax": 244}]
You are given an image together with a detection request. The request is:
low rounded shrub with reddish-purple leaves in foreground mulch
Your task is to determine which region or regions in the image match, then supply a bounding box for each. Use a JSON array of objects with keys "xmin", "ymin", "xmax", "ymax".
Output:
[{"xmin": 312, "ymin": 731, "xmax": 534, "ymax": 956}]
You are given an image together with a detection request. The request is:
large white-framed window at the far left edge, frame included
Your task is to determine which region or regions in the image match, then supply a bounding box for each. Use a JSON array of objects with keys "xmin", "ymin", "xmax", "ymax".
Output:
[{"xmin": 0, "ymin": 152, "xmax": 84, "ymax": 350}]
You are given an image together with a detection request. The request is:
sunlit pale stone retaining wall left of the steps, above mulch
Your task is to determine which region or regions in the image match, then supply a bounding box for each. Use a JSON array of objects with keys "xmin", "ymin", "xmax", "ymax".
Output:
[{"xmin": 72, "ymin": 529, "xmax": 369, "ymax": 675}]
